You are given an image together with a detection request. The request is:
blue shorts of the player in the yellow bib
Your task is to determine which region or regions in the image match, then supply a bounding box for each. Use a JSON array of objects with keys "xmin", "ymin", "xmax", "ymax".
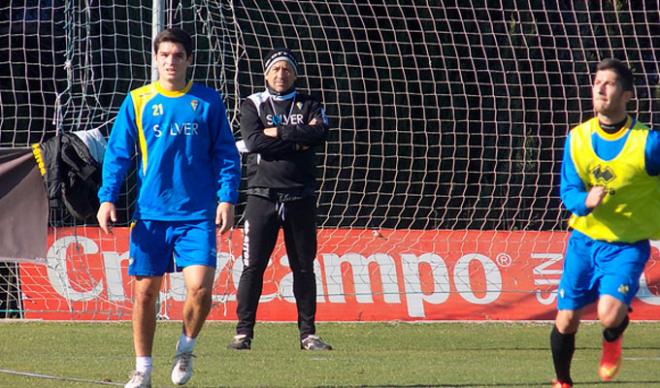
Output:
[{"xmin": 557, "ymin": 230, "xmax": 651, "ymax": 310}]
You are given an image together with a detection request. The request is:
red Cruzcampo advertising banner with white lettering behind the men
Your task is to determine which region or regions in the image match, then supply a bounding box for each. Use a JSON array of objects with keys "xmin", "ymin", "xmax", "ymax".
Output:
[{"xmin": 20, "ymin": 227, "xmax": 660, "ymax": 321}]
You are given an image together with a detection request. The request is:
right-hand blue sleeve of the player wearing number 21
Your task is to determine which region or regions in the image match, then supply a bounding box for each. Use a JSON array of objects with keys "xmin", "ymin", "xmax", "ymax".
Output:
[{"xmin": 210, "ymin": 94, "xmax": 241, "ymax": 204}]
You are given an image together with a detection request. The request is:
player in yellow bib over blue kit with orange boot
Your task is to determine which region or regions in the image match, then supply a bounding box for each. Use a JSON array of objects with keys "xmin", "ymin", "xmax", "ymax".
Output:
[{"xmin": 550, "ymin": 59, "xmax": 660, "ymax": 388}]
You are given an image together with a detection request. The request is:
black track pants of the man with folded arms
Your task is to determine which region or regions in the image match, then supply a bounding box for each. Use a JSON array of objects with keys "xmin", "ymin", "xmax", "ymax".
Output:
[{"xmin": 236, "ymin": 195, "xmax": 317, "ymax": 338}]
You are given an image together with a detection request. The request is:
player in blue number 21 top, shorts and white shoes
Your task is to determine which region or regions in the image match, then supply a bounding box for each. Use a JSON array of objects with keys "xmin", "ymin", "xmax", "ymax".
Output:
[{"xmin": 97, "ymin": 29, "xmax": 240, "ymax": 387}]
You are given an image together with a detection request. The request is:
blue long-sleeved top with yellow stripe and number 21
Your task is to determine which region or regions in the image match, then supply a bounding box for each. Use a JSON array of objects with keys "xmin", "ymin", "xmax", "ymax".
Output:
[{"xmin": 99, "ymin": 82, "xmax": 240, "ymax": 221}]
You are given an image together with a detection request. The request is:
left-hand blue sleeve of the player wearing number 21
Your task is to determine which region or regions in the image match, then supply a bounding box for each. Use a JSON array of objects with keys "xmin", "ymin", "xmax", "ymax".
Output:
[{"xmin": 98, "ymin": 94, "xmax": 137, "ymax": 203}]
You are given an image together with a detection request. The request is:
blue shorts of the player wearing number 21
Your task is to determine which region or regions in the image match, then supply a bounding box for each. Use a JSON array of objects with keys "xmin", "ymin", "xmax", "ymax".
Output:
[{"xmin": 128, "ymin": 220, "xmax": 217, "ymax": 276}]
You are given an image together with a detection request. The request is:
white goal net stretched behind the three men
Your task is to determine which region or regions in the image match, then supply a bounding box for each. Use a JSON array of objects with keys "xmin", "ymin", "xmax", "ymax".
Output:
[{"xmin": 0, "ymin": 0, "xmax": 660, "ymax": 320}]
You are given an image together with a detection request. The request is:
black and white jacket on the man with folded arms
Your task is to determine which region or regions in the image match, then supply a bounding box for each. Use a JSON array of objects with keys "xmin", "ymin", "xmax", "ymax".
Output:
[{"xmin": 241, "ymin": 91, "xmax": 328, "ymax": 200}]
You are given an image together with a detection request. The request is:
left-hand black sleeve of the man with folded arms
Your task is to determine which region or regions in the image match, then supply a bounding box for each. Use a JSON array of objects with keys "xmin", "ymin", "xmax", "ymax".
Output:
[{"xmin": 241, "ymin": 99, "xmax": 296, "ymax": 157}]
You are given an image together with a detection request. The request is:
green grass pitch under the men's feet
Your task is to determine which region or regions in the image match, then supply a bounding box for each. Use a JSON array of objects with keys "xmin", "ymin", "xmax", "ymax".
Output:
[{"xmin": 0, "ymin": 321, "xmax": 660, "ymax": 387}]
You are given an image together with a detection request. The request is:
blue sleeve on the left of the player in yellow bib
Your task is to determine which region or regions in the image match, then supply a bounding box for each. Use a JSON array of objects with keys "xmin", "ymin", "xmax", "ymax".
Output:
[{"xmin": 559, "ymin": 134, "xmax": 591, "ymax": 216}]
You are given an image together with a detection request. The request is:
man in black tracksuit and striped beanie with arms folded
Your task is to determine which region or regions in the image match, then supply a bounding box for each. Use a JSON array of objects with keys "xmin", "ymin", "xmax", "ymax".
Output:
[{"xmin": 229, "ymin": 49, "xmax": 331, "ymax": 350}]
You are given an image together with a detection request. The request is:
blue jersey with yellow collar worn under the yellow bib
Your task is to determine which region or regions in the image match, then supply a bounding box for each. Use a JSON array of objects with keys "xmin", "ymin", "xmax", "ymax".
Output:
[{"xmin": 560, "ymin": 118, "xmax": 660, "ymax": 216}]
